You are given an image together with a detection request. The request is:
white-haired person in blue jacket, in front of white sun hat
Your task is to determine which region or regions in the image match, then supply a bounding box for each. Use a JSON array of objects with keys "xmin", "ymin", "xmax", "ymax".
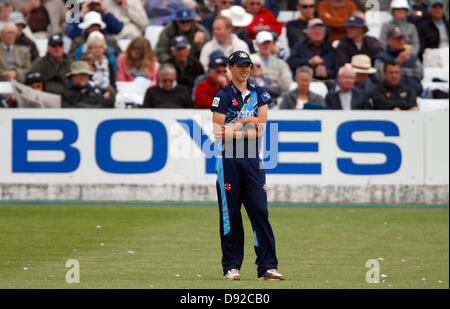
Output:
[{"xmin": 75, "ymin": 31, "xmax": 117, "ymax": 92}]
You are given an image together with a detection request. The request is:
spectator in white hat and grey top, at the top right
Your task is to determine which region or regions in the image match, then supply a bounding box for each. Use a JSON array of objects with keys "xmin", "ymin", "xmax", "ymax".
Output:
[{"xmin": 379, "ymin": 0, "xmax": 420, "ymax": 55}]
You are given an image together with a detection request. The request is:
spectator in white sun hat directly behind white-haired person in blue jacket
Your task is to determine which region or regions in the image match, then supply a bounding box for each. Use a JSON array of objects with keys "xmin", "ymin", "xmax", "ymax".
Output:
[{"xmin": 69, "ymin": 11, "xmax": 121, "ymax": 60}]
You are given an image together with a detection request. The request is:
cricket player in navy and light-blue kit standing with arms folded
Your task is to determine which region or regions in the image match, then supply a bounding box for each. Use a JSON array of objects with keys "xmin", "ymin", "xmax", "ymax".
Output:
[{"xmin": 211, "ymin": 51, "xmax": 285, "ymax": 280}]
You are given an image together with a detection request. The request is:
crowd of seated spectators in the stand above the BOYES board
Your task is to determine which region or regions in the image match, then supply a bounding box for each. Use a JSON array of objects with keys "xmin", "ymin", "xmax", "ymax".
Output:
[{"xmin": 0, "ymin": 0, "xmax": 449, "ymax": 110}]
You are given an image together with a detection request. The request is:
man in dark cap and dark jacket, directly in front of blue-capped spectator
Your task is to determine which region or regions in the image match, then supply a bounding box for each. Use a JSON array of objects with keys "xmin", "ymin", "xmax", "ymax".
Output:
[{"xmin": 166, "ymin": 35, "xmax": 205, "ymax": 97}]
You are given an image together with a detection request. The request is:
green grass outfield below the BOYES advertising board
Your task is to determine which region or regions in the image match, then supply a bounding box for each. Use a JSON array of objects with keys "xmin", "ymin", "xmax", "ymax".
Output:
[{"xmin": 0, "ymin": 202, "xmax": 449, "ymax": 289}]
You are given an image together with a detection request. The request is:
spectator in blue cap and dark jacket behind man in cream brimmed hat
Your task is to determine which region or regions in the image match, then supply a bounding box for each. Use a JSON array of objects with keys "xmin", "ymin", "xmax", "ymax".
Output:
[{"xmin": 334, "ymin": 15, "xmax": 383, "ymax": 68}]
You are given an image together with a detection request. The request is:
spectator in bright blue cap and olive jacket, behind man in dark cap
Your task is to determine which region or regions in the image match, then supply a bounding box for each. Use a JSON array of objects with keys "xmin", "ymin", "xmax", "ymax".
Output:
[{"xmin": 156, "ymin": 7, "xmax": 211, "ymax": 62}]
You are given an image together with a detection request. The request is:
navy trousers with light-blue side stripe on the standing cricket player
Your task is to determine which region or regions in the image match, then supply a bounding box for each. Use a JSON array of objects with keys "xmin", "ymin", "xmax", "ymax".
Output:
[{"xmin": 216, "ymin": 157, "xmax": 278, "ymax": 277}]
